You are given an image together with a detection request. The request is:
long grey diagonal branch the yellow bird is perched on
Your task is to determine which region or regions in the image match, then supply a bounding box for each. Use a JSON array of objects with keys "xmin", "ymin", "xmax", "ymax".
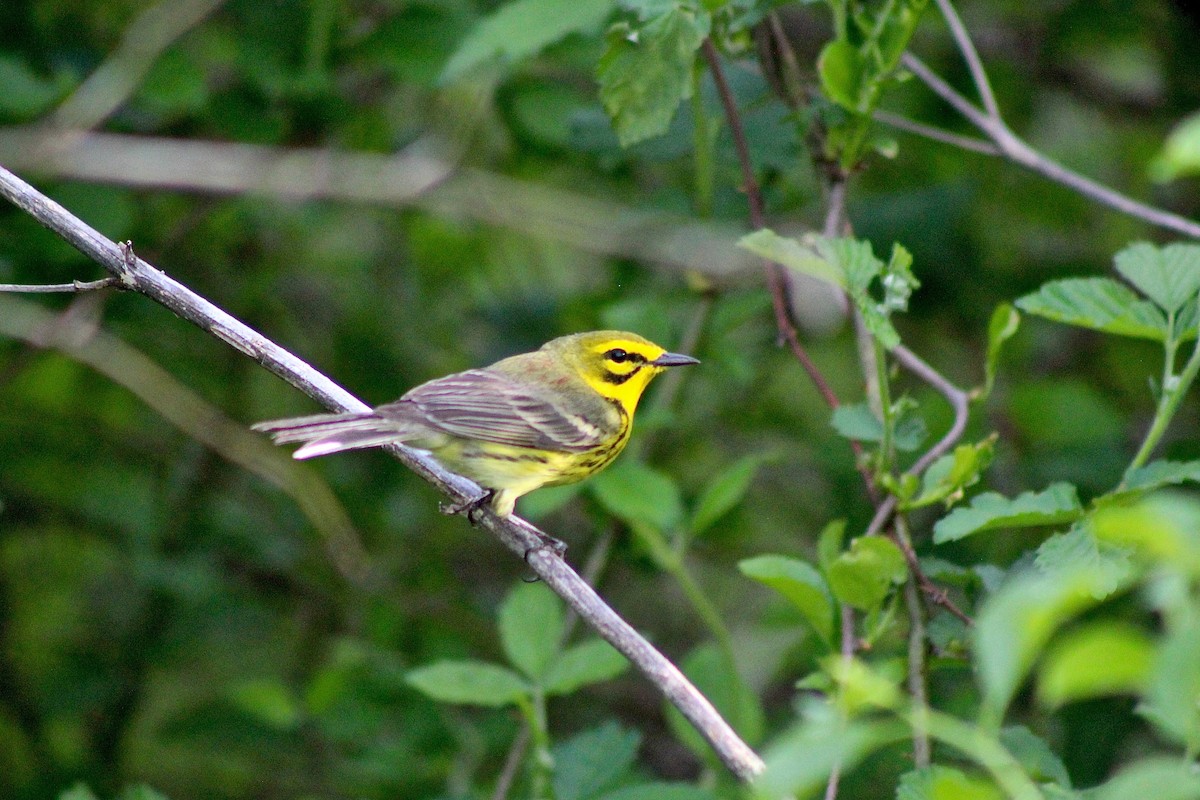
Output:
[{"xmin": 0, "ymin": 168, "xmax": 764, "ymax": 781}]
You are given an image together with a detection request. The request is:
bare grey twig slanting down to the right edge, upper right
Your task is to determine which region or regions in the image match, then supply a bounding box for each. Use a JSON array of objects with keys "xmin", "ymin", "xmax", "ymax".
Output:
[{"xmin": 902, "ymin": 53, "xmax": 1200, "ymax": 239}]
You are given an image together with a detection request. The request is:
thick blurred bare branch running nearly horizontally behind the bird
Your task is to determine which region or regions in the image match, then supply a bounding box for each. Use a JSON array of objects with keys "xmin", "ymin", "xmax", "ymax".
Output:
[{"xmin": 0, "ymin": 127, "xmax": 761, "ymax": 282}]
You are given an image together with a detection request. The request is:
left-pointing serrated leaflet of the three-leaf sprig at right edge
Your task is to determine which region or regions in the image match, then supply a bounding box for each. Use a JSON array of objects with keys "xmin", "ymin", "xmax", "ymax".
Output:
[{"xmin": 1016, "ymin": 278, "xmax": 1166, "ymax": 342}]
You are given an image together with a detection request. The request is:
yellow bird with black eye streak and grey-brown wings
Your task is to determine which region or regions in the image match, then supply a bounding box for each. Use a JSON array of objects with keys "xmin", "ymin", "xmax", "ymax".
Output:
[{"xmin": 253, "ymin": 331, "xmax": 700, "ymax": 518}]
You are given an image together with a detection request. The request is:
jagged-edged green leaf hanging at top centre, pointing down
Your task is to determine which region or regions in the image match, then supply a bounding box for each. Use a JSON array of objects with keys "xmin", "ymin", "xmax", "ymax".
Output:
[{"xmin": 596, "ymin": 7, "xmax": 710, "ymax": 148}]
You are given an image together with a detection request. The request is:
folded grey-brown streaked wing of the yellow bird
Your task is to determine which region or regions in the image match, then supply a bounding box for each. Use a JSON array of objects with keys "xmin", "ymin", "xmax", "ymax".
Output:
[{"xmin": 376, "ymin": 369, "xmax": 608, "ymax": 452}]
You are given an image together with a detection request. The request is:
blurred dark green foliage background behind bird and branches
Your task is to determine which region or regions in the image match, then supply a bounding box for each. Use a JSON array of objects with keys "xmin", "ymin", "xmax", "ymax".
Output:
[{"xmin": 0, "ymin": 0, "xmax": 1200, "ymax": 800}]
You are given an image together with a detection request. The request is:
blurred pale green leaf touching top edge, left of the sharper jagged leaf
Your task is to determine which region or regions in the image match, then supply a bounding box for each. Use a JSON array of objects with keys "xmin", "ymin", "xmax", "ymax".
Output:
[{"xmin": 440, "ymin": 0, "xmax": 616, "ymax": 84}]
